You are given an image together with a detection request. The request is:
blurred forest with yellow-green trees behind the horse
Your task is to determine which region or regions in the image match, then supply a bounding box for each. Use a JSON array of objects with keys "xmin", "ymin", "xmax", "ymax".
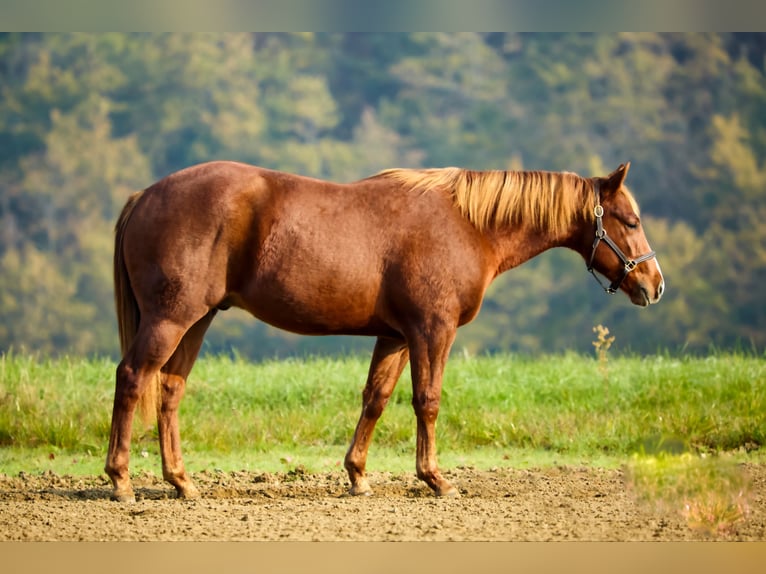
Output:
[{"xmin": 0, "ymin": 32, "xmax": 766, "ymax": 359}]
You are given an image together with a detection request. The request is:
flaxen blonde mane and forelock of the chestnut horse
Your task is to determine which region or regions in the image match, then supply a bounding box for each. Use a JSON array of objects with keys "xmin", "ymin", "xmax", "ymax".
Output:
[{"xmin": 378, "ymin": 167, "xmax": 608, "ymax": 235}]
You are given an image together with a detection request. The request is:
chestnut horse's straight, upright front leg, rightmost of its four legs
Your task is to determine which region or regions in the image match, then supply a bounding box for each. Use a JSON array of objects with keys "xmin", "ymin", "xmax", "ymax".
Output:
[{"xmin": 411, "ymin": 329, "xmax": 459, "ymax": 496}]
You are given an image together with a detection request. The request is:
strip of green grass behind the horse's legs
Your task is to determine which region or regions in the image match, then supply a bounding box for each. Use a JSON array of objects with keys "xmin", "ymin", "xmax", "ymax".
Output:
[{"xmin": 0, "ymin": 353, "xmax": 766, "ymax": 474}]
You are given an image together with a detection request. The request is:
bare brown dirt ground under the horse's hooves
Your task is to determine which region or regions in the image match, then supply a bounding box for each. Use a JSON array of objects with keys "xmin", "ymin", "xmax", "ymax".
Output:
[{"xmin": 0, "ymin": 465, "xmax": 766, "ymax": 541}]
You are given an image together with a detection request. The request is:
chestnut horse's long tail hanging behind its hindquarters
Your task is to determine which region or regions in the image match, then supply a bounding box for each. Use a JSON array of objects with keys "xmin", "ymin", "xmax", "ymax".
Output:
[{"xmin": 114, "ymin": 191, "xmax": 162, "ymax": 426}]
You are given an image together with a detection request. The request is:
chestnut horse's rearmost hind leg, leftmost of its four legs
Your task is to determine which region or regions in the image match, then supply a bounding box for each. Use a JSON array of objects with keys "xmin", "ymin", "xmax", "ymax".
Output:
[{"xmin": 104, "ymin": 320, "xmax": 186, "ymax": 502}]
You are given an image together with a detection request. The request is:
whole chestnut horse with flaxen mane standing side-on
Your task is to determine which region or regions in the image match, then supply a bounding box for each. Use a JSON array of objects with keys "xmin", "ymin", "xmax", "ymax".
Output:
[{"xmin": 105, "ymin": 161, "xmax": 665, "ymax": 502}]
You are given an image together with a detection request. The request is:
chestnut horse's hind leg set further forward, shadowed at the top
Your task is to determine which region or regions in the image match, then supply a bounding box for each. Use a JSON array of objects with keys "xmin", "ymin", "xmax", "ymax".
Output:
[{"xmin": 157, "ymin": 310, "xmax": 216, "ymax": 498}]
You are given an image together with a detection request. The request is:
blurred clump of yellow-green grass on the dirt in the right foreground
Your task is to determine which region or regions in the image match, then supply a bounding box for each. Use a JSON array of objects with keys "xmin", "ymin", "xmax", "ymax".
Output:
[{"xmin": 627, "ymin": 453, "xmax": 750, "ymax": 536}]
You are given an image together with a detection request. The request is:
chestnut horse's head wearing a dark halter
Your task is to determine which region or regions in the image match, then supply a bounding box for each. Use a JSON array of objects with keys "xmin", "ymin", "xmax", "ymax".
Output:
[{"xmin": 583, "ymin": 163, "xmax": 665, "ymax": 307}]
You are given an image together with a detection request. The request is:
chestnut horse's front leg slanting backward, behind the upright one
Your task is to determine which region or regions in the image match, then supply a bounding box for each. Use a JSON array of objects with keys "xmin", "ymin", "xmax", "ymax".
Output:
[{"xmin": 344, "ymin": 337, "xmax": 409, "ymax": 495}]
